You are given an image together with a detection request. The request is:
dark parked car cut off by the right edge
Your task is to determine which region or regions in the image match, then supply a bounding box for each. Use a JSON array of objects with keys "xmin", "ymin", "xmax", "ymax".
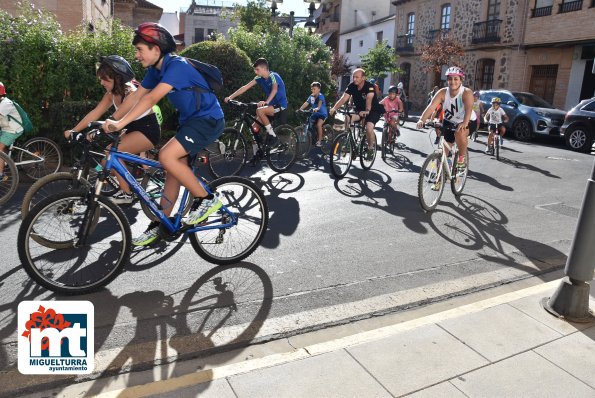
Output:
[{"xmin": 560, "ymin": 97, "xmax": 595, "ymax": 152}]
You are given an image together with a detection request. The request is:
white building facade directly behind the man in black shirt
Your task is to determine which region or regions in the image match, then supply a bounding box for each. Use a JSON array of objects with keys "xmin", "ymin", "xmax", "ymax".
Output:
[{"xmin": 338, "ymin": 0, "xmax": 395, "ymax": 92}]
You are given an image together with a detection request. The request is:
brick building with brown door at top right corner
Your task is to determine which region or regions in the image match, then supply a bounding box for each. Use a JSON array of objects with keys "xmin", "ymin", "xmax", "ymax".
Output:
[{"xmin": 511, "ymin": 0, "xmax": 595, "ymax": 109}]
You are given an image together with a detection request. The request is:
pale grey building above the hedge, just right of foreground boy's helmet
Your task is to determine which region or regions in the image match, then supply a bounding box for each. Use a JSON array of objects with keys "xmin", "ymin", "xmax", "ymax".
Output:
[{"xmin": 181, "ymin": 0, "xmax": 237, "ymax": 46}]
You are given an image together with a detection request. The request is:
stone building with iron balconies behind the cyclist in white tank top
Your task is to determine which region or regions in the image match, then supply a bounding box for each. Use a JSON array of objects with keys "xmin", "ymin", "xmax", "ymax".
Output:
[{"xmin": 392, "ymin": 0, "xmax": 529, "ymax": 110}]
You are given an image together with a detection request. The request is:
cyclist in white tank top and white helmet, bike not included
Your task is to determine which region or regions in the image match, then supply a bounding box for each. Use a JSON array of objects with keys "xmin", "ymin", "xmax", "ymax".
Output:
[{"xmin": 417, "ymin": 66, "xmax": 477, "ymax": 169}]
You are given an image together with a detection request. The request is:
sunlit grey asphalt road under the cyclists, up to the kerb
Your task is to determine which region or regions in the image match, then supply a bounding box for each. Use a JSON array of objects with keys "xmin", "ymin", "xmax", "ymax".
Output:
[{"xmin": 0, "ymin": 123, "xmax": 594, "ymax": 395}]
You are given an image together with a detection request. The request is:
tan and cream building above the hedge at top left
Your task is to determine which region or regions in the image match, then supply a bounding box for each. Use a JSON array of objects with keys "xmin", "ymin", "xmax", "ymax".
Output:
[{"xmin": 0, "ymin": 0, "xmax": 113, "ymax": 31}]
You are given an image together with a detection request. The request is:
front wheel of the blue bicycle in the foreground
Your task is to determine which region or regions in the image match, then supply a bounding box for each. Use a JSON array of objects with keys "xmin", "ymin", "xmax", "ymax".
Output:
[{"xmin": 17, "ymin": 191, "xmax": 132, "ymax": 294}]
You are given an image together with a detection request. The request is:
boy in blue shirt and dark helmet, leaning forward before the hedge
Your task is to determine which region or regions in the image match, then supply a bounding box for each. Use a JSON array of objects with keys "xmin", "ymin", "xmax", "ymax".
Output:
[{"xmin": 224, "ymin": 58, "xmax": 287, "ymax": 137}]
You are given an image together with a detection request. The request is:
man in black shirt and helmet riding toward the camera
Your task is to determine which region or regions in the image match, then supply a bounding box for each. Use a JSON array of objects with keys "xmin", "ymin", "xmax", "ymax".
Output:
[{"xmin": 329, "ymin": 68, "xmax": 384, "ymax": 156}]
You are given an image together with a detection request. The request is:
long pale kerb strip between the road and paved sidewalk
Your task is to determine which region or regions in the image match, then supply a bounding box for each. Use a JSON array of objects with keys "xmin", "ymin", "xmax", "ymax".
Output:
[{"xmin": 98, "ymin": 280, "xmax": 560, "ymax": 398}]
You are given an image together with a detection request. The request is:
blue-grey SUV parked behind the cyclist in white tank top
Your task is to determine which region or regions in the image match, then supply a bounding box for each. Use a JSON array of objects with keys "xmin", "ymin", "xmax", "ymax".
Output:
[{"xmin": 479, "ymin": 90, "xmax": 566, "ymax": 141}]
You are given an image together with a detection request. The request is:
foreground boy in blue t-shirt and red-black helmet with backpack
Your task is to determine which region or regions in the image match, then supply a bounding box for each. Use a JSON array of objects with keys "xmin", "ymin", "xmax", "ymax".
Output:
[{"xmin": 104, "ymin": 22, "xmax": 225, "ymax": 246}]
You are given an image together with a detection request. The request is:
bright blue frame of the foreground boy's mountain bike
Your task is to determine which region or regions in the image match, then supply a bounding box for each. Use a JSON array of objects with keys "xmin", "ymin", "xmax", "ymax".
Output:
[{"xmin": 101, "ymin": 146, "xmax": 238, "ymax": 234}]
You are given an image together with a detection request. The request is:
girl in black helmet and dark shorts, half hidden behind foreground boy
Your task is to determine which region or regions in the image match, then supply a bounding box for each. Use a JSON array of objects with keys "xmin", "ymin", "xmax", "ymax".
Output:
[{"xmin": 64, "ymin": 55, "xmax": 161, "ymax": 204}]
